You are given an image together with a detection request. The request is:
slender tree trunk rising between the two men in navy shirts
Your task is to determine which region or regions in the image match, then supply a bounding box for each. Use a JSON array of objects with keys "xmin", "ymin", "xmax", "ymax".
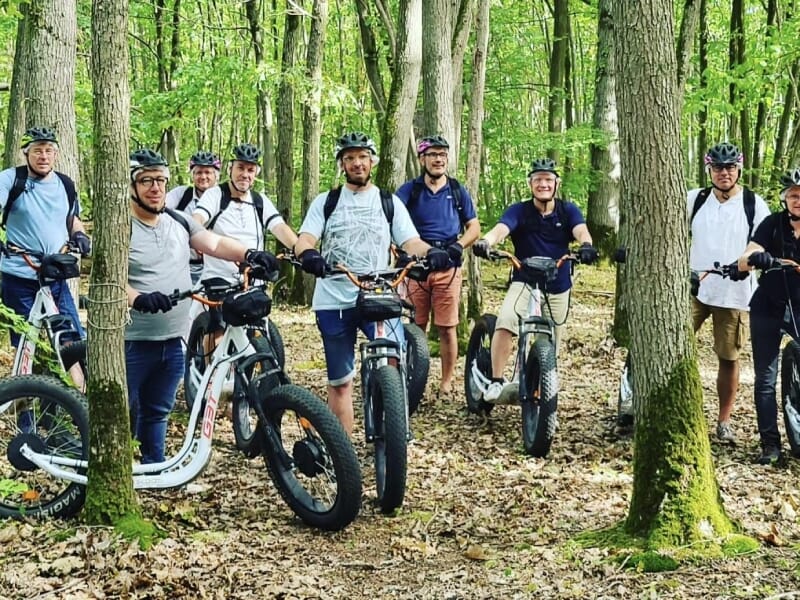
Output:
[{"xmin": 462, "ymin": 2, "xmax": 489, "ymax": 322}]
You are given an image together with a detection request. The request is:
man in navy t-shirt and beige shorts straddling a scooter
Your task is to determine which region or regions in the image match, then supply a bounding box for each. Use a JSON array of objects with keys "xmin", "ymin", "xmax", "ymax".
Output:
[{"xmin": 472, "ymin": 158, "xmax": 598, "ymax": 402}]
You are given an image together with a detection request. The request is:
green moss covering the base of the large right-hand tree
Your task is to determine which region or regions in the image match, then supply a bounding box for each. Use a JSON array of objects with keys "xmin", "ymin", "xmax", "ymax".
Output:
[{"xmin": 625, "ymin": 359, "xmax": 735, "ymax": 548}]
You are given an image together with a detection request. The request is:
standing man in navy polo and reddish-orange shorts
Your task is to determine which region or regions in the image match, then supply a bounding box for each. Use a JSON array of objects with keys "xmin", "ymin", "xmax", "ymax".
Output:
[{"xmin": 397, "ymin": 135, "xmax": 481, "ymax": 394}]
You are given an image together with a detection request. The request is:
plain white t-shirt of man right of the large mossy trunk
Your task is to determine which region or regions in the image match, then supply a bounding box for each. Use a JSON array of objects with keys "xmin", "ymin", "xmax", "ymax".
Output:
[{"xmin": 686, "ymin": 189, "xmax": 769, "ymax": 310}]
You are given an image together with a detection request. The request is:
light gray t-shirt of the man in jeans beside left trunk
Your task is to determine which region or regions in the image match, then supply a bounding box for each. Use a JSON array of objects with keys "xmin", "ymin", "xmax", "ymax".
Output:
[{"xmin": 125, "ymin": 213, "xmax": 203, "ymax": 341}]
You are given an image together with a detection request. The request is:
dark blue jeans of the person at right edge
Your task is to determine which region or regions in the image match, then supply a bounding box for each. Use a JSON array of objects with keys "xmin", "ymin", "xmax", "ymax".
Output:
[{"xmin": 750, "ymin": 309, "xmax": 800, "ymax": 448}]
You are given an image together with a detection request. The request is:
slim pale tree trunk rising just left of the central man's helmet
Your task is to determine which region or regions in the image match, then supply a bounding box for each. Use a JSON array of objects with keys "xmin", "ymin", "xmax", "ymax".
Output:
[{"xmin": 292, "ymin": 0, "xmax": 328, "ymax": 304}]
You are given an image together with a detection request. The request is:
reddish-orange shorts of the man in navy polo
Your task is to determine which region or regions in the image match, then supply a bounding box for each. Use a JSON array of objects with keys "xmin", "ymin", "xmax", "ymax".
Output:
[{"xmin": 406, "ymin": 267, "xmax": 462, "ymax": 329}]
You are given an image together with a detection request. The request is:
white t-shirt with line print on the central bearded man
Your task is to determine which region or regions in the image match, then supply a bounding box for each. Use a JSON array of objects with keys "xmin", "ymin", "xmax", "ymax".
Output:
[{"xmin": 299, "ymin": 185, "xmax": 419, "ymax": 310}]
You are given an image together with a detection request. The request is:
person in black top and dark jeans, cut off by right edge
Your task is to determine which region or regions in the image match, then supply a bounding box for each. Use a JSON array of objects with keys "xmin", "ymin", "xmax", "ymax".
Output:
[{"xmin": 738, "ymin": 168, "xmax": 800, "ymax": 465}]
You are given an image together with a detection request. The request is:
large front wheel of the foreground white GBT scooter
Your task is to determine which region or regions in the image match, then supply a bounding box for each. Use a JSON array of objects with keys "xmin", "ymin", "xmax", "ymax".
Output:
[{"xmin": 258, "ymin": 385, "xmax": 361, "ymax": 531}]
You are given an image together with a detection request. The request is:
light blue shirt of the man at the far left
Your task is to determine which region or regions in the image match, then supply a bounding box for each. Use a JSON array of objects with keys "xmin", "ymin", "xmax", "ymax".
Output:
[{"xmin": 0, "ymin": 168, "xmax": 78, "ymax": 279}]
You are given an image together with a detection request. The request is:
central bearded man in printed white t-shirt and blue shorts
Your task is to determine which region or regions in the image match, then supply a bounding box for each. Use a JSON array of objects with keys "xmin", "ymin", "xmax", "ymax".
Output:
[{"xmin": 295, "ymin": 132, "xmax": 450, "ymax": 433}]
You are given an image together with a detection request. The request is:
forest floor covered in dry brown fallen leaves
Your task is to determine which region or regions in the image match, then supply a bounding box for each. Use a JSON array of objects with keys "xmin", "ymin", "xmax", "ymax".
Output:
[{"xmin": 0, "ymin": 267, "xmax": 800, "ymax": 599}]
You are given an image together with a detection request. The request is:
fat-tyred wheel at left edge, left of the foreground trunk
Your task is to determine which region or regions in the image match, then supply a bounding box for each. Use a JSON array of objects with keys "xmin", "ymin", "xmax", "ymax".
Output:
[{"xmin": 0, "ymin": 375, "xmax": 89, "ymax": 518}]
